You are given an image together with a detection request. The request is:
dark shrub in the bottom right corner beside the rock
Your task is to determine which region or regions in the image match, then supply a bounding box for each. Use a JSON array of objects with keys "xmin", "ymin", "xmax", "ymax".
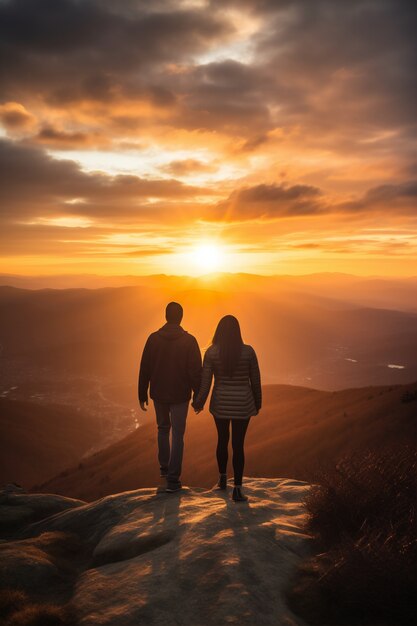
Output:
[{"xmin": 289, "ymin": 448, "xmax": 417, "ymax": 626}]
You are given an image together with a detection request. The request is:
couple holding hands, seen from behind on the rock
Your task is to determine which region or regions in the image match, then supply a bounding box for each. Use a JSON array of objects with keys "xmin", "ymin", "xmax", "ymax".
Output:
[{"xmin": 138, "ymin": 302, "xmax": 262, "ymax": 501}]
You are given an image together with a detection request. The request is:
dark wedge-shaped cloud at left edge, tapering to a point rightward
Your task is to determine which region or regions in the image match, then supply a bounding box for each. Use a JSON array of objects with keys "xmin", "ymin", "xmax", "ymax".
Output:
[{"xmin": 0, "ymin": 140, "xmax": 209, "ymax": 221}]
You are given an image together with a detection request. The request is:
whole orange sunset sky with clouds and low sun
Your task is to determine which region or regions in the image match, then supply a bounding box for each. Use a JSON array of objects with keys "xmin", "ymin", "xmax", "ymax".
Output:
[{"xmin": 0, "ymin": 0, "xmax": 417, "ymax": 275}]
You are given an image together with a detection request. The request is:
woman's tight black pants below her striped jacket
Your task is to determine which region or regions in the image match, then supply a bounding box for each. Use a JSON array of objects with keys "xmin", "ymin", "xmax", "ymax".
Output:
[{"xmin": 214, "ymin": 417, "xmax": 250, "ymax": 485}]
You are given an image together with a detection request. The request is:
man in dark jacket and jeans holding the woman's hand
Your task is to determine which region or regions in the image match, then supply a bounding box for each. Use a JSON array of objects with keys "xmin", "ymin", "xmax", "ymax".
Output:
[{"xmin": 138, "ymin": 302, "xmax": 202, "ymax": 492}]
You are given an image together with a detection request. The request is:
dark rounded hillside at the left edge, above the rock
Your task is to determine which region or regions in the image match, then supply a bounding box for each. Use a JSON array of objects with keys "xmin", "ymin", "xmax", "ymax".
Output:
[{"xmin": 0, "ymin": 398, "xmax": 97, "ymax": 484}]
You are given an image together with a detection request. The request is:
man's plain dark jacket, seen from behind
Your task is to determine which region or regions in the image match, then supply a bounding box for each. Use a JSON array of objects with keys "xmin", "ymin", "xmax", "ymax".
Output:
[{"xmin": 138, "ymin": 324, "xmax": 201, "ymax": 404}]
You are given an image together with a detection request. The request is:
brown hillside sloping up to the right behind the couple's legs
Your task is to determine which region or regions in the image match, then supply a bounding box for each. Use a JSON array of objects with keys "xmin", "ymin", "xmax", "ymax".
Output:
[{"xmin": 36, "ymin": 383, "xmax": 417, "ymax": 500}]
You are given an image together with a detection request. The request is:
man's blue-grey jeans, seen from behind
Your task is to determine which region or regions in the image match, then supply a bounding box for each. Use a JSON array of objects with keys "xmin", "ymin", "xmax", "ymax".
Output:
[{"xmin": 154, "ymin": 401, "xmax": 188, "ymax": 485}]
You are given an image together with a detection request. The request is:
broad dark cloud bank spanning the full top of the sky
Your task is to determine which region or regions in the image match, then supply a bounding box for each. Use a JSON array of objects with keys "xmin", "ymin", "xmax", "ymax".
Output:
[{"xmin": 0, "ymin": 0, "xmax": 417, "ymax": 146}]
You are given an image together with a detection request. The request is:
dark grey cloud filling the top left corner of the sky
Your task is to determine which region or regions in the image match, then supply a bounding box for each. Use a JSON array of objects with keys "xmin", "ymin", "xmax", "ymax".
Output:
[{"xmin": 0, "ymin": 0, "xmax": 232, "ymax": 104}]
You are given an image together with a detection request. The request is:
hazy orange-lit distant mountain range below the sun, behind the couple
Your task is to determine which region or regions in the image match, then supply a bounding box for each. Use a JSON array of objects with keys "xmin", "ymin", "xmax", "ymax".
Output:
[{"xmin": 0, "ymin": 274, "xmax": 417, "ymax": 398}]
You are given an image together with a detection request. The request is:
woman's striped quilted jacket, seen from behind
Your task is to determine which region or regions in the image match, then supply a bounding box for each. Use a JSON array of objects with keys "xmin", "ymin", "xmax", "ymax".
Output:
[{"xmin": 193, "ymin": 344, "xmax": 262, "ymax": 419}]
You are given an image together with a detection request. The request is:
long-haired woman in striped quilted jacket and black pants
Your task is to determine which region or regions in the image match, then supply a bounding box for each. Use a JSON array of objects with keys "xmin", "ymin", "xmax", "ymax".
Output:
[{"xmin": 193, "ymin": 315, "xmax": 262, "ymax": 502}]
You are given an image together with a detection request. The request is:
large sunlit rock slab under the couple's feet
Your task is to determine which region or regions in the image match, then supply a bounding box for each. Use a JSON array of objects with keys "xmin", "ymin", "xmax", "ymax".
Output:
[{"xmin": 0, "ymin": 478, "xmax": 309, "ymax": 626}]
